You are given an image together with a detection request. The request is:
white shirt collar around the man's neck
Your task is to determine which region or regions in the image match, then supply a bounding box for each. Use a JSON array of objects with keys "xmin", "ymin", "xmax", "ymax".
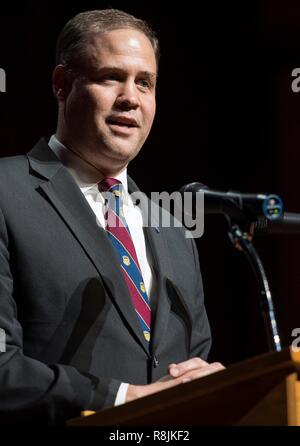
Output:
[{"xmin": 48, "ymin": 135, "xmax": 133, "ymax": 205}]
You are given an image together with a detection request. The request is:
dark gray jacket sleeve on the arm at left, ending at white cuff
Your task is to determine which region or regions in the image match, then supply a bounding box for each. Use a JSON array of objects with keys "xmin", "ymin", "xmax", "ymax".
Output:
[{"xmin": 0, "ymin": 210, "xmax": 120, "ymax": 424}]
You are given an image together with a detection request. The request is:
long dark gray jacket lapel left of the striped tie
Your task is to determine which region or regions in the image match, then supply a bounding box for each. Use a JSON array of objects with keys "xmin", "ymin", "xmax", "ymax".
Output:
[{"xmin": 28, "ymin": 139, "xmax": 149, "ymax": 353}]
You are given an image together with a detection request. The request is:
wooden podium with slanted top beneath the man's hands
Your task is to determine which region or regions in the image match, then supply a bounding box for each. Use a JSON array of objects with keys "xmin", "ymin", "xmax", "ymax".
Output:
[{"xmin": 67, "ymin": 348, "xmax": 300, "ymax": 426}]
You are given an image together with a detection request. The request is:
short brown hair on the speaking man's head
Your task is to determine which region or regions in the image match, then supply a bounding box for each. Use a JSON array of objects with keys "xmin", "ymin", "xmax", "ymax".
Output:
[{"xmin": 56, "ymin": 9, "xmax": 159, "ymax": 70}]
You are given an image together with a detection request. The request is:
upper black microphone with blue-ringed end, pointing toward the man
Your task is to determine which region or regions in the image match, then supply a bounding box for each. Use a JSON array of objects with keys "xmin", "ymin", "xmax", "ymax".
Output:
[{"xmin": 180, "ymin": 182, "xmax": 283, "ymax": 221}]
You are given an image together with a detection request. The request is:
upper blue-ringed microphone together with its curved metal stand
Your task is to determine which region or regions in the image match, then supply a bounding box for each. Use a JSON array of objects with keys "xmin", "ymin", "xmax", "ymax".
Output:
[{"xmin": 180, "ymin": 183, "xmax": 283, "ymax": 351}]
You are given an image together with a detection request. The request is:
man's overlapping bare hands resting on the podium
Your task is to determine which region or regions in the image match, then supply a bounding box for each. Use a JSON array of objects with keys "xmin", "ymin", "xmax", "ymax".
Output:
[{"xmin": 126, "ymin": 358, "xmax": 225, "ymax": 403}]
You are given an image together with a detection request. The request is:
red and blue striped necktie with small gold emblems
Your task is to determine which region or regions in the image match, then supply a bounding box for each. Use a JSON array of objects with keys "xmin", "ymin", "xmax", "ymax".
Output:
[{"xmin": 99, "ymin": 178, "xmax": 151, "ymax": 342}]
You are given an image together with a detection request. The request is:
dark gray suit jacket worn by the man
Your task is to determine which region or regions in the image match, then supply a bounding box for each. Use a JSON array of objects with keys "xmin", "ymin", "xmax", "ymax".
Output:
[{"xmin": 0, "ymin": 139, "xmax": 210, "ymax": 424}]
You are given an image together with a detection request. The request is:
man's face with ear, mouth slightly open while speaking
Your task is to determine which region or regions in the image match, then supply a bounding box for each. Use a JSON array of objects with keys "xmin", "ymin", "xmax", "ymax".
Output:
[{"xmin": 64, "ymin": 29, "xmax": 157, "ymax": 170}]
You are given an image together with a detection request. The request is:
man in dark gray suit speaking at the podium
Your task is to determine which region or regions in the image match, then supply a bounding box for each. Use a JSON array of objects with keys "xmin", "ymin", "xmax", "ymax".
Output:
[{"xmin": 0, "ymin": 10, "xmax": 222, "ymax": 423}]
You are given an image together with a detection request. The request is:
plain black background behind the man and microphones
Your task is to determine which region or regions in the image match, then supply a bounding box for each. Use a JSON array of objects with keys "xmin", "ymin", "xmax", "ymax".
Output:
[{"xmin": 0, "ymin": 0, "xmax": 300, "ymax": 364}]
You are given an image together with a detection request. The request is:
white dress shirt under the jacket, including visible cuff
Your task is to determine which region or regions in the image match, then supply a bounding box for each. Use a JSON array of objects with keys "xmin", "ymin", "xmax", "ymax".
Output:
[{"xmin": 48, "ymin": 135, "xmax": 154, "ymax": 406}]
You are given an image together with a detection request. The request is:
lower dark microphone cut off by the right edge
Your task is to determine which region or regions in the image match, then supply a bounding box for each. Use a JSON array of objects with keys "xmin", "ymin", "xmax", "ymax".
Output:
[{"xmin": 252, "ymin": 212, "xmax": 300, "ymax": 235}]
